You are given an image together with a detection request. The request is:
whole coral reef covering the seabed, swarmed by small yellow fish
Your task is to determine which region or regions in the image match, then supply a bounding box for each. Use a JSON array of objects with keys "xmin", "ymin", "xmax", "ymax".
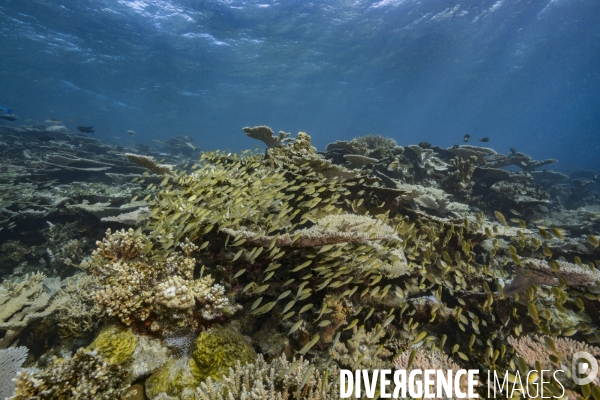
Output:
[{"xmin": 0, "ymin": 127, "xmax": 600, "ymax": 400}]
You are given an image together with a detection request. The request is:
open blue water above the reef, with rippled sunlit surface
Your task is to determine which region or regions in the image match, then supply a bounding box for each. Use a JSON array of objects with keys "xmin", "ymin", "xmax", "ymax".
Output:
[{"xmin": 0, "ymin": 0, "xmax": 600, "ymax": 169}]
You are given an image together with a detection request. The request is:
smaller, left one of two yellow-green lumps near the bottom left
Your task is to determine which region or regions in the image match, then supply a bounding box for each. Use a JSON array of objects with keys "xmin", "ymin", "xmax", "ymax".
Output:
[{"xmin": 88, "ymin": 325, "xmax": 138, "ymax": 364}]
